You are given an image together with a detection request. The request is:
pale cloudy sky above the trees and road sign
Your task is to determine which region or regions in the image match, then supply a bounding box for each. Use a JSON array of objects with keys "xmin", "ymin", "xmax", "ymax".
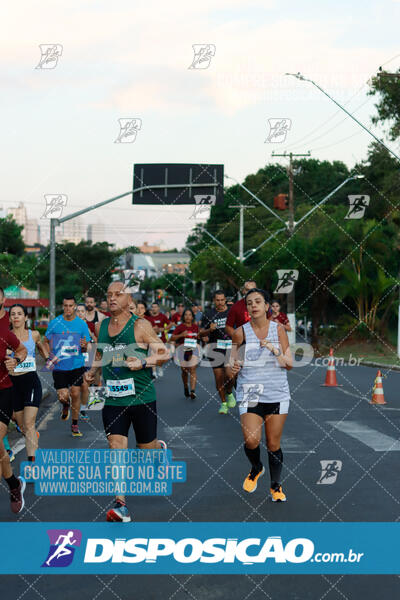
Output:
[{"xmin": 0, "ymin": 0, "xmax": 400, "ymax": 248}]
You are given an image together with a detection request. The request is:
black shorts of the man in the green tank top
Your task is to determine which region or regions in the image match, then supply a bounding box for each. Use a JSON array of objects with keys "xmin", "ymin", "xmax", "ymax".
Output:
[{"xmin": 102, "ymin": 400, "xmax": 157, "ymax": 444}]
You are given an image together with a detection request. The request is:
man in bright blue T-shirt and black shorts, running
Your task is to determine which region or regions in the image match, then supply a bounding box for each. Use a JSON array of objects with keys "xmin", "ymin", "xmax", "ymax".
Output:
[{"xmin": 43, "ymin": 296, "xmax": 90, "ymax": 437}]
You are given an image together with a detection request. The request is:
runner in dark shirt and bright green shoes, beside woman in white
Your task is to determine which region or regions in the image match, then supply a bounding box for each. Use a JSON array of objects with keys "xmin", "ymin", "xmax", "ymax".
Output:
[{"xmin": 200, "ymin": 290, "xmax": 236, "ymax": 415}]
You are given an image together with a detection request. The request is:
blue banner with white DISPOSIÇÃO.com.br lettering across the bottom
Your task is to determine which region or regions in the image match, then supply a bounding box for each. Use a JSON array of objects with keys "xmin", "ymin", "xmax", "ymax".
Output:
[{"xmin": 0, "ymin": 522, "xmax": 400, "ymax": 575}]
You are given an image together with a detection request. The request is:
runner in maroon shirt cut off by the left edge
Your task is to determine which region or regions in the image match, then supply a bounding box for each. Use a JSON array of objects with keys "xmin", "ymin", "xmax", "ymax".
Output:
[{"xmin": 0, "ymin": 288, "xmax": 27, "ymax": 513}]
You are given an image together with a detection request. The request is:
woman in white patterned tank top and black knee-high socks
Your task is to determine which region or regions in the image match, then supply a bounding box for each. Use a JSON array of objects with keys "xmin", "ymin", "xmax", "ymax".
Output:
[{"xmin": 230, "ymin": 288, "xmax": 293, "ymax": 502}]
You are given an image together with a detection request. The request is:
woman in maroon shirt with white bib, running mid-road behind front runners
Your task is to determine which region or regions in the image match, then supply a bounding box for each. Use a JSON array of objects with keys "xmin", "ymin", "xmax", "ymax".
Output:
[{"xmin": 171, "ymin": 308, "xmax": 199, "ymax": 400}]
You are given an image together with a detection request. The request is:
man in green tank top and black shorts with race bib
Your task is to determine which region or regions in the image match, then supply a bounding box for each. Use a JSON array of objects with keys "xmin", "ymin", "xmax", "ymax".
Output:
[{"xmin": 86, "ymin": 281, "xmax": 170, "ymax": 523}]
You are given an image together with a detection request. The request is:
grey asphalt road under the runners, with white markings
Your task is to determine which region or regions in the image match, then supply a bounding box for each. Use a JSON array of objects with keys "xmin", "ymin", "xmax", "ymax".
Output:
[{"xmin": 0, "ymin": 356, "xmax": 400, "ymax": 600}]
